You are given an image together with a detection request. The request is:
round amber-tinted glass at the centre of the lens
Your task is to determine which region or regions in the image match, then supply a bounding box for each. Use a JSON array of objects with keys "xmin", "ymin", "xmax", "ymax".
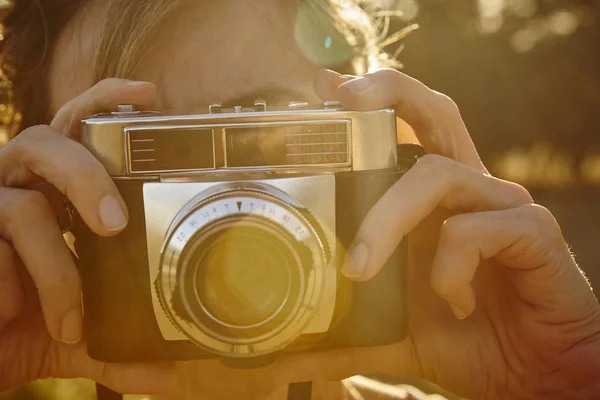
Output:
[{"xmin": 188, "ymin": 220, "xmax": 297, "ymax": 327}]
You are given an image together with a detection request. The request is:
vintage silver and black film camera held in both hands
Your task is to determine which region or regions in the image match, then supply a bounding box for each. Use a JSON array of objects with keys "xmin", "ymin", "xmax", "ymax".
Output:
[{"xmin": 73, "ymin": 101, "xmax": 422, "ymax": 363}]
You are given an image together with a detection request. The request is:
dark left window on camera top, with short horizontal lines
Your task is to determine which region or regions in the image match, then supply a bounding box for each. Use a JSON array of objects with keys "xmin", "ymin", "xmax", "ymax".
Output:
[{"xmin": 128, "ymin": 128, "xmax": 215, "ymax": 173}]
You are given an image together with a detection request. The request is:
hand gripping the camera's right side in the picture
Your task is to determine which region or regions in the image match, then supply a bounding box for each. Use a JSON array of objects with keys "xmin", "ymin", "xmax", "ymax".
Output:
[{"xmin": 308, "ymin": 70, "xmax": 600, "ymax": 399}]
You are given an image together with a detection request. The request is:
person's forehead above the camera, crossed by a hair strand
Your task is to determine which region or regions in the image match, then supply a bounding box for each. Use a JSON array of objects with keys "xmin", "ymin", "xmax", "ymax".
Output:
[{"xmin": 50, "ymin": 0, "xmax": 316, "ymax": 115}]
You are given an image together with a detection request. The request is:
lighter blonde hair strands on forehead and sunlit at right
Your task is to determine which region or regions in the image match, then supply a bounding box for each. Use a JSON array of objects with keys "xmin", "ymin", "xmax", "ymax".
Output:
[{"xmin": 94, "ymin": 0, "xmax": 416, "ymax": 81}]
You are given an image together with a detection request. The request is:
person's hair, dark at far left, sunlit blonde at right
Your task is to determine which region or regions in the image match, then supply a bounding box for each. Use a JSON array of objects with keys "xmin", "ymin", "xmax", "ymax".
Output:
[{"xmin": 0, "ymin": 0, "xmax": 407, "ymax": 135}]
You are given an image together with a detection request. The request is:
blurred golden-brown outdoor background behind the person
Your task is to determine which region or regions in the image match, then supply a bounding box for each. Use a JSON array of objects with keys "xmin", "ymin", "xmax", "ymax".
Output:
[{"xmin": 0, "ymin": 0, "xmax": 600, "ymax": 399}]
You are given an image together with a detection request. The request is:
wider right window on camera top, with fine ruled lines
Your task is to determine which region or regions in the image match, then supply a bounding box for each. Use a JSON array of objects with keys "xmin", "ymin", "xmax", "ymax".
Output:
[{"xmin": 225, "ymin": 122, "xmax": 348, "ymax": 167}]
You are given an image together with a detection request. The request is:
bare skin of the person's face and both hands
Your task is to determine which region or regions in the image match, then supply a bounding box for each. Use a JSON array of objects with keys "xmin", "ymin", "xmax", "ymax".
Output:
[{"xmin": 0, "ymin": 1, "xmax": 600, "ymax": 399}]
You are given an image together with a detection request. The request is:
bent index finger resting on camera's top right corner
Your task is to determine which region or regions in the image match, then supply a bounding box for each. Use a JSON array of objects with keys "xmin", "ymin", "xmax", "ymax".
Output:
[{"xmin": 322, "ymin": 69, "xmax": 486, "ymax": 171}]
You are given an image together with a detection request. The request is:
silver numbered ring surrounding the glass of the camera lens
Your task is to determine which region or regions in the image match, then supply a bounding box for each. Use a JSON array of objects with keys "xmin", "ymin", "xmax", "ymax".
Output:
[{"xmin": 155, "ymin": 183, "xmax": 329, "ymax": 357}]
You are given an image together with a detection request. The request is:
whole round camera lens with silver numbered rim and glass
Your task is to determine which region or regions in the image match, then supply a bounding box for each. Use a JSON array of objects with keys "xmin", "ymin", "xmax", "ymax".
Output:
[{"xmin": 155, "ymin": 182, "xmax": 329, "ymax": 357}]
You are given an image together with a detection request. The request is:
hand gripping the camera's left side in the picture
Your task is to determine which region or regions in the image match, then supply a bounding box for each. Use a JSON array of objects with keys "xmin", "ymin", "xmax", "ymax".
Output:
[{"xmin": 0, "ymin": 79, "xmax": 176, "ymax": 394}]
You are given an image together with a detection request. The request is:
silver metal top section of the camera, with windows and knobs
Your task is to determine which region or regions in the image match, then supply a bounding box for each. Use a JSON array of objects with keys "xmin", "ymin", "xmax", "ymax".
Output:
[{"xmin": 82, "ymin": 100, "xmax": 396, "ymax": 179}]
